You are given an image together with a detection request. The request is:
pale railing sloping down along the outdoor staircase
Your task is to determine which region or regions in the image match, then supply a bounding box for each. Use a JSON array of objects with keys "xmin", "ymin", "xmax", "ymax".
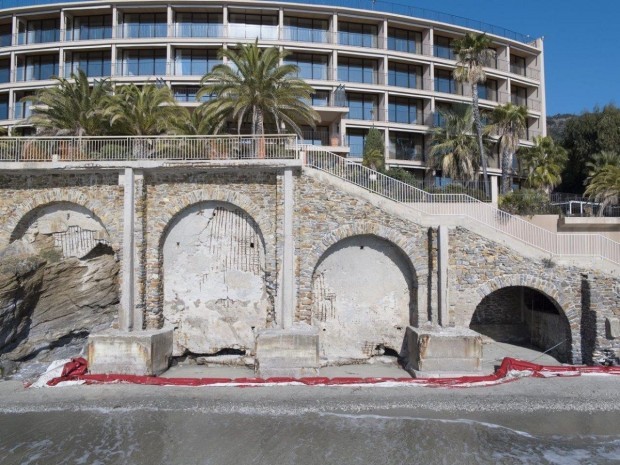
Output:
[{"xmin": 305, "ymin": 147, "xmax": 620, "ymax": 264}]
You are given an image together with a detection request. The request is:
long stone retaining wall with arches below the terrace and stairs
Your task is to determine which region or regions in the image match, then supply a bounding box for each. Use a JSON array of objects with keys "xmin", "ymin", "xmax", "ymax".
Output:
[{"xmin": 0, "ymin": 160, "xmax": 620, "ymax": 370}]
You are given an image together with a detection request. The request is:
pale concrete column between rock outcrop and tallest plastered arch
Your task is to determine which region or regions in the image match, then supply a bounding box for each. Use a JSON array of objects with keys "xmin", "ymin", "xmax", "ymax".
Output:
[{"xmin": 119, "ymin": 168, "xmax": 135, "ymax": 331}]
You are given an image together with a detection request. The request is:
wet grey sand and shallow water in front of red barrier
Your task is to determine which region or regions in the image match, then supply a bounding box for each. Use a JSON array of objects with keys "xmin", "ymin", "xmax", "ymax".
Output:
[{"xmin": 0, "ymin": 376, "xmax": 620, "ymax": 465}]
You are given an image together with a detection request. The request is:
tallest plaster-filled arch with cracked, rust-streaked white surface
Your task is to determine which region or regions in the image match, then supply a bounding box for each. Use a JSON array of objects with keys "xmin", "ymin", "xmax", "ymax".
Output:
[{"xmin": 162, "ymin": 201, "xmax": 273, "ymax": 356}]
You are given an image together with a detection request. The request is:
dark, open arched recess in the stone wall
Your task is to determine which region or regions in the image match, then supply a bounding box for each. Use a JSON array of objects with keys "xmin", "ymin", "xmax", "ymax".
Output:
[{"xmin": 470, "ymin": 286, "xmax": 571, "ymax": 362}]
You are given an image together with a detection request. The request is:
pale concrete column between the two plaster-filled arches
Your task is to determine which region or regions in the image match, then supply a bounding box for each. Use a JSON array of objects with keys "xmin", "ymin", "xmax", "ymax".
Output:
[{"xmin": 280, "ymin": 168, "xmax": 295, "ymax": 329}]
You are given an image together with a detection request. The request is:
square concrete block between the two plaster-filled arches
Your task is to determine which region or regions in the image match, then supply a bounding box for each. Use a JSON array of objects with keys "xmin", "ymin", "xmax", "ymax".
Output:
[{"xmin": 256, "ymin": 324, "xmax": 320, "ymax": 378}]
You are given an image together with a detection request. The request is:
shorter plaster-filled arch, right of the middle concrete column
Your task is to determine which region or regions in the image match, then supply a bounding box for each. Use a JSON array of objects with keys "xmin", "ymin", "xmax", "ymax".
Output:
[{"xmin": 312, "ymin": 235, "xmax": 417, "ymax": 364}]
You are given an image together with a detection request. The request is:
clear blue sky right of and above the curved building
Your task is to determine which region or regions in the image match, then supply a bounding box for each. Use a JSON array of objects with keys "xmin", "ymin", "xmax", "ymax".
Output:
[{"xmin": 404, "ymin": 0, "xmax": 620, "ymax": 115}]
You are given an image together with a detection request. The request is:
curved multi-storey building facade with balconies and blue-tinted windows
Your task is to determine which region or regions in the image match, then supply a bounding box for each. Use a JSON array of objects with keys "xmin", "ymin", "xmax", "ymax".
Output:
[{"xmin": 0, "ymin": 0, "xmax": 546, "ymax": 176}]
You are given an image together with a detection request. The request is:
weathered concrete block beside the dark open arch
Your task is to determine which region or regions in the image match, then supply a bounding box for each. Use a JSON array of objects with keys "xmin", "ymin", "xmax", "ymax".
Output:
[{"xmin": 406, "ymin": 326, "xmax": 482, "ymax": 373}]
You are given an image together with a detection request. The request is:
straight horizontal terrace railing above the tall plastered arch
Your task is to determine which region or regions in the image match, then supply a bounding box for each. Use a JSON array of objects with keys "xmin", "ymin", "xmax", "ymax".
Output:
[{"xmin": 0, "ymin": 135, "xmax": 297, "ymax": 162}]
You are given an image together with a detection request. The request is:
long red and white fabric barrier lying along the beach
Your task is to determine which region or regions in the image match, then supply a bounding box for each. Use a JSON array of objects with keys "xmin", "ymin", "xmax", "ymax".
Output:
[{"xmin": 33, "ymin": 357, "xmax": 620, "ymax": 388}]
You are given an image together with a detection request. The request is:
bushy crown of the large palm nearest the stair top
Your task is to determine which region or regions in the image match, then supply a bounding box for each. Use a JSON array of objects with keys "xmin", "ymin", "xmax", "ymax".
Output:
[{"xmin": 198, "ymin": 40, "xmax": 320, "ymax": 135}]
